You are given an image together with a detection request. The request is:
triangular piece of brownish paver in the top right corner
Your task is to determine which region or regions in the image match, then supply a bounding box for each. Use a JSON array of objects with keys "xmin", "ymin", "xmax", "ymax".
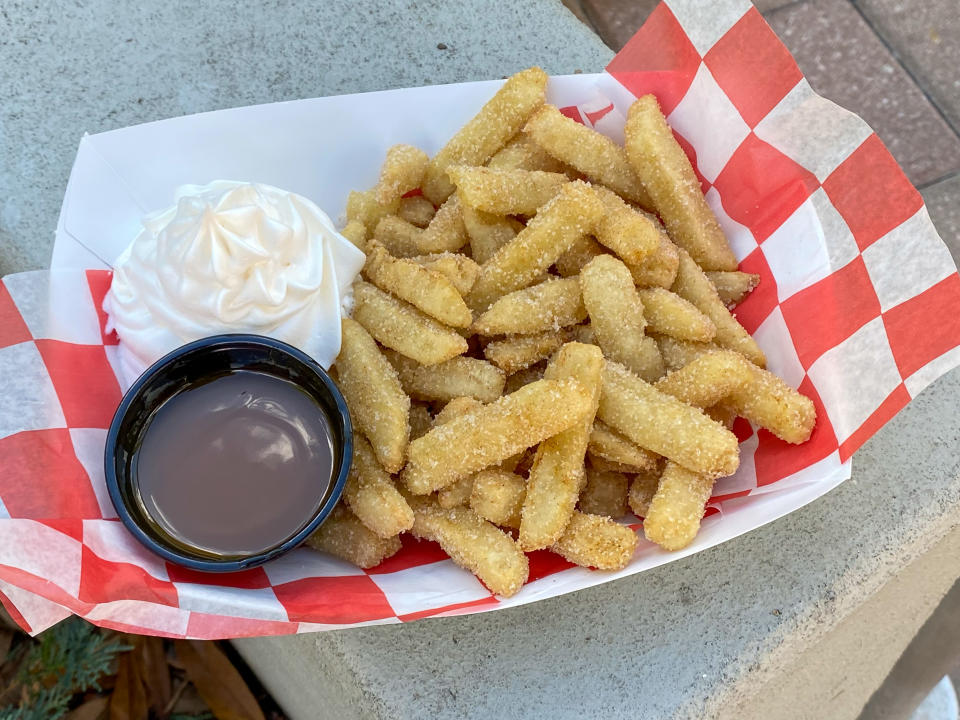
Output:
[{"xmin": 856, "ymin": 0, "xmax": 960, "ymax": 140}]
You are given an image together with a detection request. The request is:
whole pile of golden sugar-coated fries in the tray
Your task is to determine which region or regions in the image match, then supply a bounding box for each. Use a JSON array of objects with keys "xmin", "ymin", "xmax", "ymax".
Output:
[{"xmin": 310, "ymin": 68, "xmax": 815, "ymax": 596}]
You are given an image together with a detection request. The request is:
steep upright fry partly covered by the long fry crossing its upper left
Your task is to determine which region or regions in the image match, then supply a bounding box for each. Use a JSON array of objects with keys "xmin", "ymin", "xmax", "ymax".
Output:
[{"xmin": 518, "ymin": 343, "xmax": 603, "ymax": 550}]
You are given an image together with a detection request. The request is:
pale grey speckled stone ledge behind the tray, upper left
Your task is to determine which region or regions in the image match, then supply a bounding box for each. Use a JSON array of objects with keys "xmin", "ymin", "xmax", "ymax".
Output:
[{"xmin": 0, "ymin": 0, "xmax": 612, "ymax": 275}]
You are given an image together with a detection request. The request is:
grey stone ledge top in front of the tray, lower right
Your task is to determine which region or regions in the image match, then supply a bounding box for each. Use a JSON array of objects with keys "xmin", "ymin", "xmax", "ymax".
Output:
[{"xmin": 235, "ymin": 371, "xmax": 960, "ymax": 720}]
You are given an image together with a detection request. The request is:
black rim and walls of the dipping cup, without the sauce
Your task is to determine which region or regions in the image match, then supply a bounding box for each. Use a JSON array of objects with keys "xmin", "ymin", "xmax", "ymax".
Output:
[{"xmin": 104, "ymin": 334, "xmax": 353, "ymax": 572}]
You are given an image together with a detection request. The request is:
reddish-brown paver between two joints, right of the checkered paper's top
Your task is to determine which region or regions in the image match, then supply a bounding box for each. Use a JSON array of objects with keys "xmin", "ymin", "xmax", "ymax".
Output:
[{"xmin": 767, "ymin": 0, "xmax": 960, "ymax": 185}]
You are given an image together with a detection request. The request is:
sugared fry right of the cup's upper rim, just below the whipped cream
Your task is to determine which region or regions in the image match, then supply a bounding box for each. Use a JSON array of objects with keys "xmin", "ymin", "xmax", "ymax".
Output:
[{"xmin": 335, "ymin": 318, "xmax": 410, "ymax": 473}]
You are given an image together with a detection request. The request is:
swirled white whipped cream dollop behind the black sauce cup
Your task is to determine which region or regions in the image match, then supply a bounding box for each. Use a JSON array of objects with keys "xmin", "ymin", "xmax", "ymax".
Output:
[{"xmin": 104, "ymin": 180, "xmax": 364, "ymax": 384}]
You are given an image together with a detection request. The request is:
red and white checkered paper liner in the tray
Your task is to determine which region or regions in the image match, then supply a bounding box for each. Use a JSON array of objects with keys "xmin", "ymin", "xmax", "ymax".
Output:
[{"xmin": 0, "ymin": 0, "xmax": 960, "ymax": 638}]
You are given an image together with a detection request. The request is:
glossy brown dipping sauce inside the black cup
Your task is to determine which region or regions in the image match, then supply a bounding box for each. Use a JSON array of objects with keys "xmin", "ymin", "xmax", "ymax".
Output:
[{"xmin": 135, "ymin": 370, "xmax": 333, "ymax": 555}]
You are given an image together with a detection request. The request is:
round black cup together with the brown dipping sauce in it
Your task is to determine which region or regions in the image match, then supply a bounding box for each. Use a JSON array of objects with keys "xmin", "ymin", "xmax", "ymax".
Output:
[{"xmin": 104, "ymin": 335, "xmax": 353, "ymax": 572}]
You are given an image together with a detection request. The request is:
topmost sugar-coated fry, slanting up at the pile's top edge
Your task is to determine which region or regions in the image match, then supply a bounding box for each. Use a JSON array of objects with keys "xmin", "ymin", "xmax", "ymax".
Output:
[{"xmin": 423, "ymin": 67, "xmax": 547, "ymax": 205}]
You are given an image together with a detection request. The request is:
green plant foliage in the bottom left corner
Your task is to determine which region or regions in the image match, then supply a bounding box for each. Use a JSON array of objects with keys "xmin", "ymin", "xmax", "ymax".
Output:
[{"xmin": 0, "ymin": 617, "xmax": 130, "ymax": 720}]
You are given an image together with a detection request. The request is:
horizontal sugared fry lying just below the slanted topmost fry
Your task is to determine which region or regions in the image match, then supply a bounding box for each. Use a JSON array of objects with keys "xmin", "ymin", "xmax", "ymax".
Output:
[{"xmin": 447, "ymin": 165, "xmax": 570, "ymax": 215}]
